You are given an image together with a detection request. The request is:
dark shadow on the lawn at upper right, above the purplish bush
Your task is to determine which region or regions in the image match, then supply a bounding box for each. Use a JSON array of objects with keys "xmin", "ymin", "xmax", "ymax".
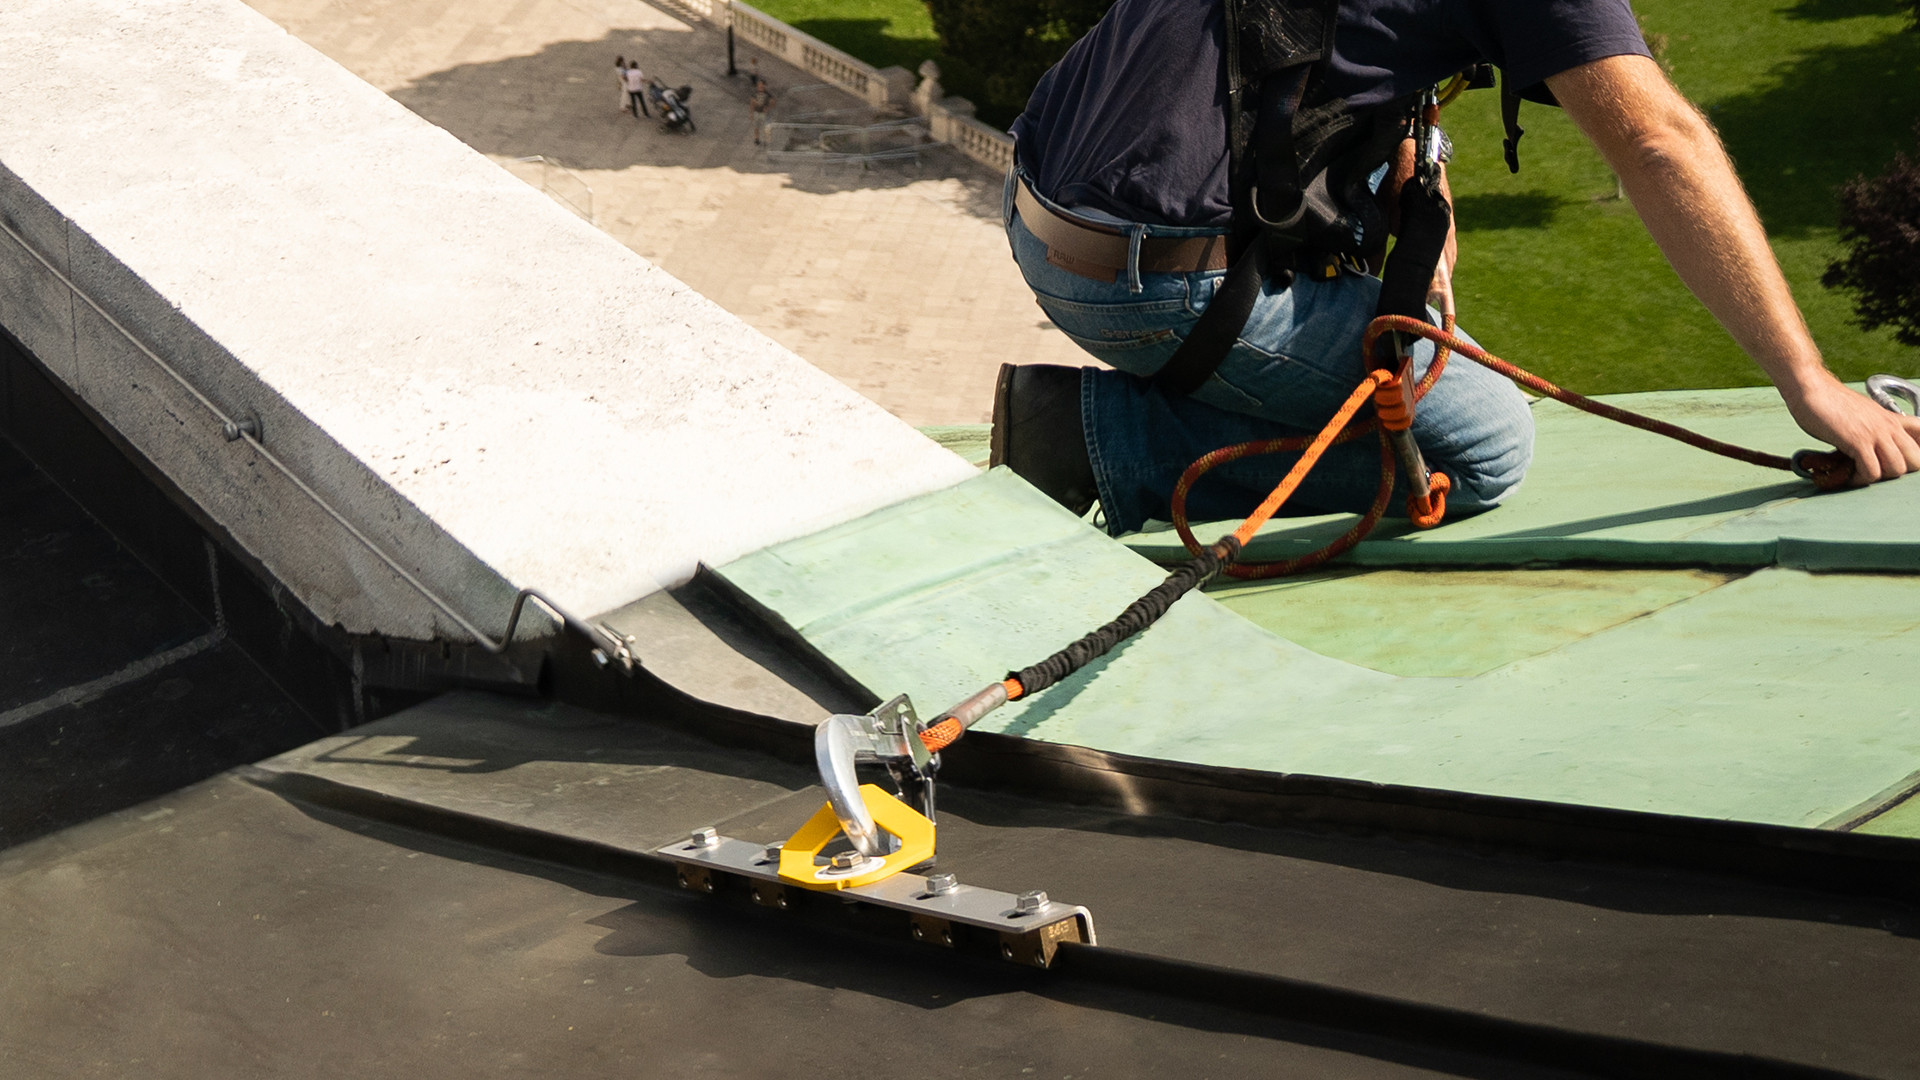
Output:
[{"xmin": 1711, "ymin": 25, "xmax": 1920, "ymax": 236}]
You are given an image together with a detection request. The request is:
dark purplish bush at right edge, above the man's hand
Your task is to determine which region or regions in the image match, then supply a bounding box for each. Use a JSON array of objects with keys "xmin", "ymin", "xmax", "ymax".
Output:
[{"xmin": 1820, "ymin": 125, "xmax": 1920, "ymax": 346}]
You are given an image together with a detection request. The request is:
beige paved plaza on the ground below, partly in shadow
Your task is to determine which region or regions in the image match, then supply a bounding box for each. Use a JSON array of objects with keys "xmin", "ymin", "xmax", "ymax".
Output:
[{"xmin": 248, "ymin": 0, "xmax": 1087, "ymax": 425}]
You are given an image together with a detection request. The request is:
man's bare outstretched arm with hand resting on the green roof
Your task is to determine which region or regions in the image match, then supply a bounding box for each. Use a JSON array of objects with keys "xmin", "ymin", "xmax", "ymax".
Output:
[{"xmin": 1548, "ymin": 56, "xmax": 1920, "ymax": 484}]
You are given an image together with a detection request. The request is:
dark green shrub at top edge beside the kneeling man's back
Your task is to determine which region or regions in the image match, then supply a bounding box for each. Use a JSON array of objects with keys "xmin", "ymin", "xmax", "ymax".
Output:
[{"xmin": 927, "ymin": 0, "xmax": 1114, "ymax": 123}]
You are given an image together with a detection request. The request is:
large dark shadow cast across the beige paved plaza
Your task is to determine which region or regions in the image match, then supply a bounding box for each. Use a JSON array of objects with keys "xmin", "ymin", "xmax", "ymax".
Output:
[{"xmin": 378, "ymin": 28, "xmax": 1000, "ymax": 204}]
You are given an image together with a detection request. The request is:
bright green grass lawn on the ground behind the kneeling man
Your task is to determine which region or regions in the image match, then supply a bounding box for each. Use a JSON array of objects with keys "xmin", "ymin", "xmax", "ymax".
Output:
[{"xmin": 760, "ymin": 0, "xmax": 1920, "ymax": 392}]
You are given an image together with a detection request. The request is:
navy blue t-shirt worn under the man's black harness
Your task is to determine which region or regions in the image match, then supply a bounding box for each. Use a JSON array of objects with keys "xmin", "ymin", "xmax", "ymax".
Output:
[{"xmin": 1014, "ymin": 0, "xmax": 1647, "ymax": 229}]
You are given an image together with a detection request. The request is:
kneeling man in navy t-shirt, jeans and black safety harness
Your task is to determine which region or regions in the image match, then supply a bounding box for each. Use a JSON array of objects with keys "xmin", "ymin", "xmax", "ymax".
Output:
[{"xmin": 991, "ymin": 0, "xmax": 1920, "ymax": 536}]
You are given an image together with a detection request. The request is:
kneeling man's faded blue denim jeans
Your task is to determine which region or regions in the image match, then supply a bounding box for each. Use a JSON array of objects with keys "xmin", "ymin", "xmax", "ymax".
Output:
[{"xmin": 1006, "ymin": 179, "xmax": 1534, "ymax": 536}]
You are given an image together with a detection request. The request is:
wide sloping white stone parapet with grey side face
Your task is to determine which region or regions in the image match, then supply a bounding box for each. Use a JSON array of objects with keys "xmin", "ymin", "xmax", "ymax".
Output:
[{"xmin": 0, "ymin": 0, "xmax": 973, "ymax": 640}]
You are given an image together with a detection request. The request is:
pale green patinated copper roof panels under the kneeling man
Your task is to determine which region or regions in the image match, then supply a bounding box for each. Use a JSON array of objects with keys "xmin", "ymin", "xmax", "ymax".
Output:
[{"xmin": 722, "ymin": 390, "xmax": 1920, "ymax": 826}]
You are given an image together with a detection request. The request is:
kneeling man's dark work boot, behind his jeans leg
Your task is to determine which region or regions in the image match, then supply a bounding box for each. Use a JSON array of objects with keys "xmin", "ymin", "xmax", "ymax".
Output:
[{"xmin": 987, "ymin": 363, "xmax": 1100, "ymax": 513}]
